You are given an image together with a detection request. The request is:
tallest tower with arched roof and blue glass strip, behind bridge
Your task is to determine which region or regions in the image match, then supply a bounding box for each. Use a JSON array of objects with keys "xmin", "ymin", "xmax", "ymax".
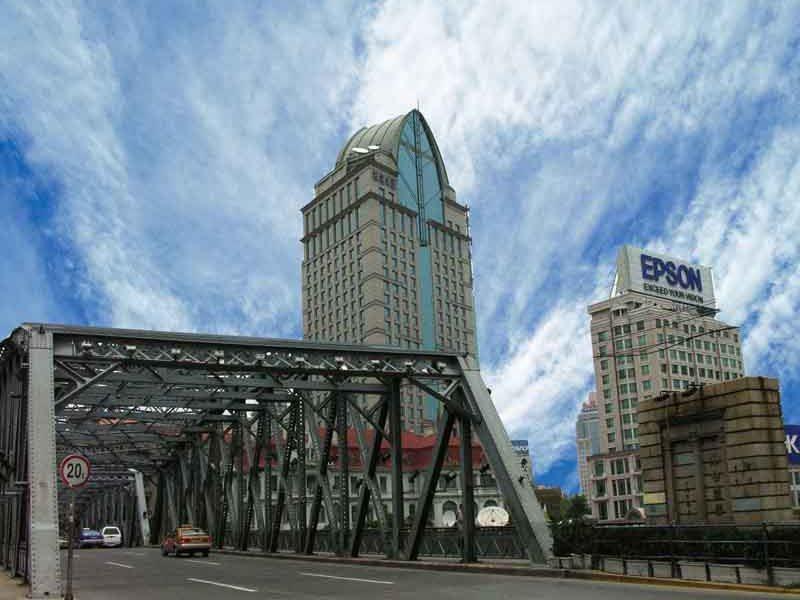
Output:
[{"xmin": 302, "ymin": 110, "xmax": 477, "ymax": 432}]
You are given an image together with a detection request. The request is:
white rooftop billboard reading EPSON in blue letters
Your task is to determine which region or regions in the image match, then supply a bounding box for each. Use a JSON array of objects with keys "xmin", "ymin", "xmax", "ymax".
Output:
[{"xmin": 616, "ymin": 246, "xmax": 716, "ymax": 308}]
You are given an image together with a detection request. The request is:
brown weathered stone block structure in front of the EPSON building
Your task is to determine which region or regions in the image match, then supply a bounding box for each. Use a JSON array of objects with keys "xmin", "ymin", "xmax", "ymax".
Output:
[{"xmin": 639, "ymin": 377, "xmax": 792, "ymax": 524}]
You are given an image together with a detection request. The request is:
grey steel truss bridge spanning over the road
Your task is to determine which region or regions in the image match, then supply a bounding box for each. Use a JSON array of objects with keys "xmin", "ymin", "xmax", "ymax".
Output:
[{"xmin": 0, "ymin": 323, "xmax": 552, "ymax": 598}]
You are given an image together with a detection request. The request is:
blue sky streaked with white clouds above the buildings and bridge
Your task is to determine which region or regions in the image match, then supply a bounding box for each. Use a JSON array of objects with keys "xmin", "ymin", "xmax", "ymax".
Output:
[{"xmin": 0, "ymin": 0, "xmax": 800, "ymax": 491}]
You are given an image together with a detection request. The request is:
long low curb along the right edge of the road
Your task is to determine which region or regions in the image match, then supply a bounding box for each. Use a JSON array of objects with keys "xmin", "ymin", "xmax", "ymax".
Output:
[{"xmin": 206, "ymin": 549, "xmax": 800, "ymax": 597}]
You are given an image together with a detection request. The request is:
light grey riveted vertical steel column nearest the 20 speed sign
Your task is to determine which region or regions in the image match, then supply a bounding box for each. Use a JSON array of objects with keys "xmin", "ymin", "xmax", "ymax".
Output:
[{"xmin": 27, "ymin": 327, "xmax": 61, "ymax": 599}]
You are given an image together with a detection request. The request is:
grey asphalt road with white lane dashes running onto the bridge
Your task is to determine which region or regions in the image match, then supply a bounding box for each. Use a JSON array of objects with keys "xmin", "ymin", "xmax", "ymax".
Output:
[{"xmin": 62, "ymin": 548, "xmax": 764, "ymax": 600}]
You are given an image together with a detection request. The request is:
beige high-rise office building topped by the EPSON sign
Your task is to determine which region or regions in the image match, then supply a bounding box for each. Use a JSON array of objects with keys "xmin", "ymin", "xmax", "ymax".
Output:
[{"xmin": 588, "ymin": 246, "xmax": 745, "ymax": 521}]
